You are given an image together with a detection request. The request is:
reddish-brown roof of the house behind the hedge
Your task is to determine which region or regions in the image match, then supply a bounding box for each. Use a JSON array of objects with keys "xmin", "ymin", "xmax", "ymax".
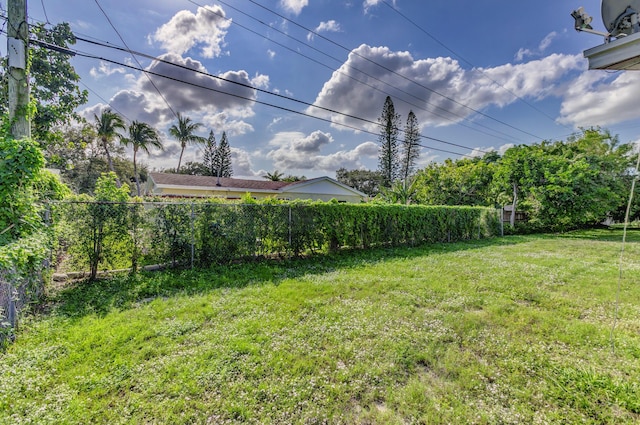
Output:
[{"xmin": 149, "ymin": 173, "xmax": 300, "ymax": 190}]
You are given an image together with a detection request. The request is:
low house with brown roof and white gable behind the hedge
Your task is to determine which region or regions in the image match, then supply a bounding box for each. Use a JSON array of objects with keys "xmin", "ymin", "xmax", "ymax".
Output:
[{"xmin": 147, "ymin": 173, "xmax": 367, "ymax": 203}]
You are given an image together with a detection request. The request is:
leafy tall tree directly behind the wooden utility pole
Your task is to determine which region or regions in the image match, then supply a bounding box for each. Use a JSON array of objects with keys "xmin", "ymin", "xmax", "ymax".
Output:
[{"xmin": 0, "ymin": 23, "xmax": 88, "ymax": 145}]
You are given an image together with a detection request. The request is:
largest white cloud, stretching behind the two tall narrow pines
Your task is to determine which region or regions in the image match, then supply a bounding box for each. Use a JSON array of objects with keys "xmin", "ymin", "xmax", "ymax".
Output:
[{"xmin": 307, "ymin": 45, "xmax": 584, "ymax": 131}]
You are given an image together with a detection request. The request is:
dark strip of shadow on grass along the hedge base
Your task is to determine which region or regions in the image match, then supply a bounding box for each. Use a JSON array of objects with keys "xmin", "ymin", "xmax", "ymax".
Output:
[{"xmin": 39, "ymin": 235, "xmax": 568, "ymax": 318}]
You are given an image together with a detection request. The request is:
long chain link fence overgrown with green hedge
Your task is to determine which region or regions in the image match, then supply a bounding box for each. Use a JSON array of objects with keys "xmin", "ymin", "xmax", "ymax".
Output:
[{"xmin": 46, "ymin": 201, "xmax": 500, "ymax": 278}]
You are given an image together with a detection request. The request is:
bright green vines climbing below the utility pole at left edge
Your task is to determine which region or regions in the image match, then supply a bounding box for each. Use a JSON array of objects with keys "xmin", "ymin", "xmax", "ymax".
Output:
[{"xmin": 0, "ymin": 135, "xmax": 68, "ymax": 345}]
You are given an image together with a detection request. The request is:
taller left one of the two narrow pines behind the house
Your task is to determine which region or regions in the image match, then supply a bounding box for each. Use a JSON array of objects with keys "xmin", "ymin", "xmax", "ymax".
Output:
[{"xmin": 378, "ymin": 96, "xmax": 400, "ymax": 187}]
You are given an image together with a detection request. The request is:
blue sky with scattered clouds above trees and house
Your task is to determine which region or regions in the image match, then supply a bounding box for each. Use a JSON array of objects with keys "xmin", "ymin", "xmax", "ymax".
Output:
[{"xmin": 0, "ymin": 0, "xmax": 640, "ymax": 178}]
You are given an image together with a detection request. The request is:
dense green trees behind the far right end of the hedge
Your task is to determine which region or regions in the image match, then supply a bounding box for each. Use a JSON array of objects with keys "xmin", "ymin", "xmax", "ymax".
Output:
[{"xmin": 417, "ymin": 129, "xmax": 638, "ymax": 231}]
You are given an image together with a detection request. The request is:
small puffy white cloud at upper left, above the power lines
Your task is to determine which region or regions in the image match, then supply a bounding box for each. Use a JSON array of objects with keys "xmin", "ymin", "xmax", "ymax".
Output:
[{"xmin": 151, "ymin": 5, "xmax": 231, "ymax": 58}]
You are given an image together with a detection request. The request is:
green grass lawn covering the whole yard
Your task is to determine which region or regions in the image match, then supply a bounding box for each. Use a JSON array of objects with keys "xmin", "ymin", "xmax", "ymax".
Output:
[{"xmin": 0, "ymin": 231, "xmax": 640, "ymax": 424}]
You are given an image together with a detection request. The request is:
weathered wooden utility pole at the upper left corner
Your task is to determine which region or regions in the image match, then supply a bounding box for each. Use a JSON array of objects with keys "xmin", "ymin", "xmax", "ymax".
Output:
[{"xmin": 7, "ymin": 0, "xmax": 31, "ymax": 139}]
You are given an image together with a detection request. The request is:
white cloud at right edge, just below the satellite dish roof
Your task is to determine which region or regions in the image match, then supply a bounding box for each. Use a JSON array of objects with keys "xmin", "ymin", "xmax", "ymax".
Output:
[{"xmin": 558, "ymin": 71, "xmax": 640, "ymax": 127}]
